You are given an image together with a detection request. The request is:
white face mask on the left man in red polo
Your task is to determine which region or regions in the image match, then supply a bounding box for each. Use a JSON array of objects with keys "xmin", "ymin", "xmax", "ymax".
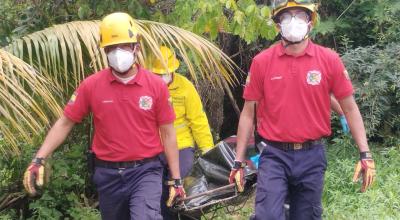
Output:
[{"xmin": 107, "ymin": 48, "xmax": 135, "ymax": 73}]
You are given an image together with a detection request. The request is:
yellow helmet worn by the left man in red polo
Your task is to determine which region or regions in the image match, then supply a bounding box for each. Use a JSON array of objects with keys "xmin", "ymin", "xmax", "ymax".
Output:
[{"xmin": 100, "ymin": 12, "xmax": 138, "ymax": 48}]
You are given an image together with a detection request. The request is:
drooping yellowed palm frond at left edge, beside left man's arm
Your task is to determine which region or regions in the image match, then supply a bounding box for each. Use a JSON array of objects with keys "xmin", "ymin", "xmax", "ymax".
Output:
[{"xmin": 0, "ymin": 49, "xmax": 61, "ymax": 156}]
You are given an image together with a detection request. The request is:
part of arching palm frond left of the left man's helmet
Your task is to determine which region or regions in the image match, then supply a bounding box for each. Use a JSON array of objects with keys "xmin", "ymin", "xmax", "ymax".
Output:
[{"xmin": 5, "ymin": 21, "xmax": 106, "ymax": 94}]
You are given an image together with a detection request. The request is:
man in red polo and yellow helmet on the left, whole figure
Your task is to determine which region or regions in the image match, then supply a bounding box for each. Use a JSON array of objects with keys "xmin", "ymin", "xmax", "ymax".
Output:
[{"xmin": 24, "ymin": 13, "xmax": 185, "ymax": 220}]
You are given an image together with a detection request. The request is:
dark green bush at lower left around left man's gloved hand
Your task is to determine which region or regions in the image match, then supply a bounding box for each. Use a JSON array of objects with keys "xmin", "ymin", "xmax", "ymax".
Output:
[{"xmin": 0, "ymin": 125, "xmax": 100, "ymax": 220}]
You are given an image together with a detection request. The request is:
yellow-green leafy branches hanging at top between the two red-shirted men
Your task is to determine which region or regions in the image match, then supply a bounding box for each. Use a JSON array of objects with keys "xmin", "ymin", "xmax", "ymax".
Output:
[{"xmin": 157, "ymin": 0, "xmax": 276, "ymax": 44}]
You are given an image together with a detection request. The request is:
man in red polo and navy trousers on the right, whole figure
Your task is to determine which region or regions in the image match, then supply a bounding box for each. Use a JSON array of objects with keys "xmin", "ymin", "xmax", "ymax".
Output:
[{"xmin": 230, "ymin": 0, "xmax": 375, "ymax": 220}]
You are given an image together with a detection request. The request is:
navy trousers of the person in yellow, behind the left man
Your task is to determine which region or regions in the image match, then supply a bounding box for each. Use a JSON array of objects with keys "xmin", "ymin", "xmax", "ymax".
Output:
[{"xmin": 161, "ymin": 147, "xmax": 194, "ymax": 220}]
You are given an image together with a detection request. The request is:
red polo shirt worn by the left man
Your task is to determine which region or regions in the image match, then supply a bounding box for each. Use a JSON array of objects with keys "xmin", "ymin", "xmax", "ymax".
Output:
[{"xmin": 64, "ymin": 66, "xmax": 175, "ymax": 161}]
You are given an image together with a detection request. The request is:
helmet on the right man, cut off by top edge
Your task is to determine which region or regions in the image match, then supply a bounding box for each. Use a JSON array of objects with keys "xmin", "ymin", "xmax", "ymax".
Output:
[{"xmin": 272, "ymin": 0, "xmax": 318, "ymax": 24}]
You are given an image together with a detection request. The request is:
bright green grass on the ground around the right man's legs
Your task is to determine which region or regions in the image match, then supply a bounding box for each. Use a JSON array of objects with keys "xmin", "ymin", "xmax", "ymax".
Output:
[{"xmin": 209, "ymin": 136, "xmax": 400, "ymax": 220}]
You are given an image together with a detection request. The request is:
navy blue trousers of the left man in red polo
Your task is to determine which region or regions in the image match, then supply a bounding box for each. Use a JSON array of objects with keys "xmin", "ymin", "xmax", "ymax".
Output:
[{"xmin": 93, "ymin": 160, "xmax": 163, "ymax": 220}]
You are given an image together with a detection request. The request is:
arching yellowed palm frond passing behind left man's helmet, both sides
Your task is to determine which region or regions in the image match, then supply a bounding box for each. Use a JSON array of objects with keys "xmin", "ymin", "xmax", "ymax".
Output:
[{"xmin": 5, "ymin": 20, "xmax": 242, "ymax": 91}]
